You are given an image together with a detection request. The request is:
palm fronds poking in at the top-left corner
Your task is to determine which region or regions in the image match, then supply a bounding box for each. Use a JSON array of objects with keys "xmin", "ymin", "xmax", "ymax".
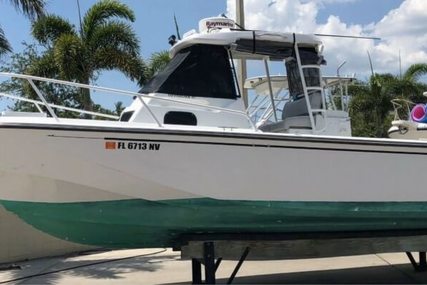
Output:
[{"xmin": 0, "ymin": 0, "xmax": 46, "ymax": 55}]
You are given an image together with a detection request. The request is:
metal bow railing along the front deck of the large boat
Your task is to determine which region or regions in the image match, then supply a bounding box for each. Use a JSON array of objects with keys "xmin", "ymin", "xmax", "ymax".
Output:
[{"xmin": 0, "ymin": 72, "xmax": 257, "ymax": 130}]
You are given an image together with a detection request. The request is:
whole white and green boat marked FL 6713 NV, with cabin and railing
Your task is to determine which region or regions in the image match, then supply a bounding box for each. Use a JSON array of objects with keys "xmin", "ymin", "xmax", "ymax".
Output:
[{"xmin": 0, "ymin": 18, "xmax": 427, "ymax": 248}]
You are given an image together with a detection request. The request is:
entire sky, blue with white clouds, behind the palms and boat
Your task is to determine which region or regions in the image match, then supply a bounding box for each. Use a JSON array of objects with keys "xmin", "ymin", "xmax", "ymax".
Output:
[{"xmin": 0, "ymin": 0, "xmax": 427, "ymax": 109}]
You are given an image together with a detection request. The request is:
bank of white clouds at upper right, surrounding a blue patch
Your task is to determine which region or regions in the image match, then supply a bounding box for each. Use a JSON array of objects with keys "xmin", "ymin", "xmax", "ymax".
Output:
[{"xmin": 227, "ymin": 0, "xmax": 427, "ymax": 78}]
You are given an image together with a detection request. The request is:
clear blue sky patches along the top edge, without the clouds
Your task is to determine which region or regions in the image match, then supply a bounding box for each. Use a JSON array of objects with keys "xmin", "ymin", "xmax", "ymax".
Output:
[{"xmin": 0, "ymin": 0, "xmax": 403, "ymax": 57}]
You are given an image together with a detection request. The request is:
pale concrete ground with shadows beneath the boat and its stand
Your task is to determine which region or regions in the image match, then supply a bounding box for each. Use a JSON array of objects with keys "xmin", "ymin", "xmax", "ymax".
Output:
[{"xmin": 0, "ymin": 249, "xmax": 427, "ymax": 285}]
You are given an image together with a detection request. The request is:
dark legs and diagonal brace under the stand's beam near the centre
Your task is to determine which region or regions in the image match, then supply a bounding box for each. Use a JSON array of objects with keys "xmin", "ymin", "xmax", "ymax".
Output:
[{"xmin": 191, "ymin": 241, "xmax": 249, "ymax": 284}]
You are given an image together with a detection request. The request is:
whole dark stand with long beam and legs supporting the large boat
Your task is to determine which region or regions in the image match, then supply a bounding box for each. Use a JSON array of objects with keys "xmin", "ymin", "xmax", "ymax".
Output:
[{"xmin": 174, "ymin": 231, "xmax": 427, "ymax": 284}]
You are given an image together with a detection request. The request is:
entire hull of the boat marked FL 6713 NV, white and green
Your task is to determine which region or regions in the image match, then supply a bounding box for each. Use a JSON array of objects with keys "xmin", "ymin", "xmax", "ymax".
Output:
[{"xmin": 0, "ymin": 121, "xmax": 427, "ymax": 247}]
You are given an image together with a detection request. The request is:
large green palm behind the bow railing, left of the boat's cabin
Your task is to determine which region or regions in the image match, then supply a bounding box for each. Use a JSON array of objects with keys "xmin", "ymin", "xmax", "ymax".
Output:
[{"xmin": 28, "ymin": 0, "xmax": 145, "ymax": 110}]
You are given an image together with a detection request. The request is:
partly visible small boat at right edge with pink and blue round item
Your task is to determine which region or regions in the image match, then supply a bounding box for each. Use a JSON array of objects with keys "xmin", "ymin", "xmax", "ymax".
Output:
[{"xmin": 388, "ymin": 92, "xmax": 427, "ymax": 140}]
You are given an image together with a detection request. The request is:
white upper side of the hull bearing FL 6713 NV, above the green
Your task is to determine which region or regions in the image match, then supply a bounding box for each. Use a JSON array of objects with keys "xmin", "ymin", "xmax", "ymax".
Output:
[{"xmin": 0, "ymin": 120, "xmax": 427, "ymax": 202}]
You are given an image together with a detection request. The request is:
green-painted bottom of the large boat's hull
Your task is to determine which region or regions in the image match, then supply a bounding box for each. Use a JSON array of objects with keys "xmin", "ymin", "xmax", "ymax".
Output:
[{"xmin": 0, "ymin": 199, "xmax": 427, "ymax": 248}]
